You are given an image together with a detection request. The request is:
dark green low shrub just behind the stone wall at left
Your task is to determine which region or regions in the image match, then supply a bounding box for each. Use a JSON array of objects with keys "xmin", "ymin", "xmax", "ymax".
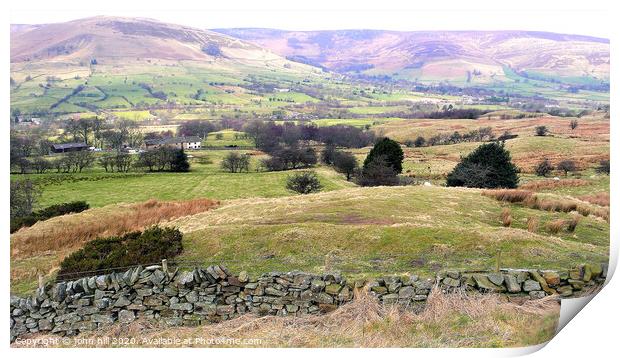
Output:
[{"xmin": 58, "ymin": 226, "xmax": 183, "ymax": 279}]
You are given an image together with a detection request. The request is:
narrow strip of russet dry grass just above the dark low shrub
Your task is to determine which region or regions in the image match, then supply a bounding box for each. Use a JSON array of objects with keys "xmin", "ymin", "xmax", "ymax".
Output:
[{"xmin": 11, "ymin": 199, "xmax": 219, "ymax": 258}]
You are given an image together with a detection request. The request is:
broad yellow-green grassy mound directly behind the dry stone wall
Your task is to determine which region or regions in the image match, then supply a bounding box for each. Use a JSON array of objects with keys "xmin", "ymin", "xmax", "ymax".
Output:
[{"xmin": 176, "ymin": 186, "xmax": 609, "ymax": 275}]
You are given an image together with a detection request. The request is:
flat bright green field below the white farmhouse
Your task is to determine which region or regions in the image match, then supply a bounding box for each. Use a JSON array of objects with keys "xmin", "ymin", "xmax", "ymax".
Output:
[{"xmin": 13, "ymin": 150, "xmax": 353, "ymax": 207}]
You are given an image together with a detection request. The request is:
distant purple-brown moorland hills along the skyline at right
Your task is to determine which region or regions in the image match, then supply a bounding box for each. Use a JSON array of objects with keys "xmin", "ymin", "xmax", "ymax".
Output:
[{"xmin": 214, "ymin": 29, "xmax": 609, "ymax": 84}]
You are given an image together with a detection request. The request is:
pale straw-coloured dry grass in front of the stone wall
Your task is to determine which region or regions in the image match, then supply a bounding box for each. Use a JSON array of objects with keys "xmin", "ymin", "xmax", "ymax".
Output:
[{"xmin": 13, "ymin": 291, "xmax": 559, "ymax": 347}]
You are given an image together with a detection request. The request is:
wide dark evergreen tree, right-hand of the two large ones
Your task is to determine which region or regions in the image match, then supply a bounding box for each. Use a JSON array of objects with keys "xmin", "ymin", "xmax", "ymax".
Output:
[{"xmin": 446, "ymin": 142, "xmax": 519, "ymax": 188}]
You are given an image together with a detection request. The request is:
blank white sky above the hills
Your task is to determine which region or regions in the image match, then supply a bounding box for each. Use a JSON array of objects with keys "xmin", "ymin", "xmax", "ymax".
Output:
[{"xmin": 9, "ymin": 0, "xmax": 612, "ymax": 38}]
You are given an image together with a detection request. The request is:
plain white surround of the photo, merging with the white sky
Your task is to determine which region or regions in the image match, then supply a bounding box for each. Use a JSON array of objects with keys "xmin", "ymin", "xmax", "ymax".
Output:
[{"xmin": 0, "ymin": 0, "xmax": 620, "ymax": 357}]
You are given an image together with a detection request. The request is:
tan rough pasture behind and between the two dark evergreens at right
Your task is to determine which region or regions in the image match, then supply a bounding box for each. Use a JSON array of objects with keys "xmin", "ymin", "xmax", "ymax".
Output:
[{"xmin": 368, "ymin": 117, "xmax": 609, "ymax": 178}]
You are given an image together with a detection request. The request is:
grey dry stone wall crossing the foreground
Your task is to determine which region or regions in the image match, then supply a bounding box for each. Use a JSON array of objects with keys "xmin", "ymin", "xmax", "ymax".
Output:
[{"xmin": 10, "ymin": 264, "xmax": 607, "ymax": 341}]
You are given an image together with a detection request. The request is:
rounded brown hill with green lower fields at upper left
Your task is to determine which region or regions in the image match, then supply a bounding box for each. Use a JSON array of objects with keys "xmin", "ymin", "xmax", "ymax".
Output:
[{"xmin": 11, "ymin": 16, "xmax": 321, "ymax": 113}]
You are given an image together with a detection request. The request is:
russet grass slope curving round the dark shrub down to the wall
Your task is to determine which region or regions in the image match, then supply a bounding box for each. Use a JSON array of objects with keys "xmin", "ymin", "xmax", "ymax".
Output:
[{"xmin": 11, "ymin": 199, "xmax": 219, "ymax": 292}]
